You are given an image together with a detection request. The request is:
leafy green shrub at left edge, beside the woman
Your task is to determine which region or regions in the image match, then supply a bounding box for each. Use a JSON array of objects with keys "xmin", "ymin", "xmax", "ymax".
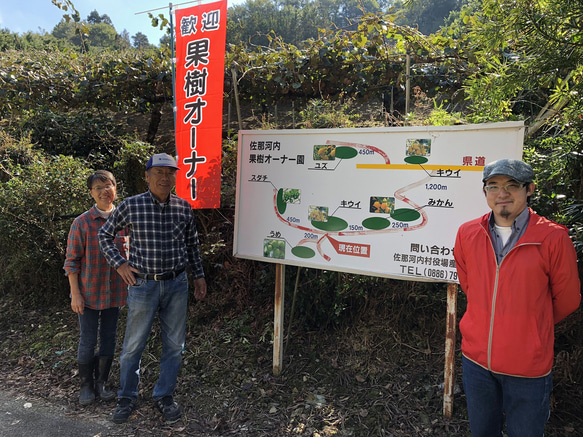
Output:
[{"xmin": 0, "ymin": 134, "xmax": 91, "ymax": 298}]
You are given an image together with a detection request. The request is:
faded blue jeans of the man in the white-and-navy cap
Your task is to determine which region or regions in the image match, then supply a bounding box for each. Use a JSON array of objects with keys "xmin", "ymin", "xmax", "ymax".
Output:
[{"xmin": 118, "ymin": 272, "xmax": 188, "ymax": 400}]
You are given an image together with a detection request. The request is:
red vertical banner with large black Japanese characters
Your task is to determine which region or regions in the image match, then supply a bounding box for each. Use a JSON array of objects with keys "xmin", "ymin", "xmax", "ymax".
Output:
[{"xmin": 174, "ymin": 0, "xmax": 227, "ymax": 208}]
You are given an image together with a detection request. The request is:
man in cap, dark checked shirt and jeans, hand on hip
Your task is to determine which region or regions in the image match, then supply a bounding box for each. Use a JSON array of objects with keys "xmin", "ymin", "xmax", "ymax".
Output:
[{"xmin": 98, "ymin": 153, "xmax": 207, "ymax": 423}]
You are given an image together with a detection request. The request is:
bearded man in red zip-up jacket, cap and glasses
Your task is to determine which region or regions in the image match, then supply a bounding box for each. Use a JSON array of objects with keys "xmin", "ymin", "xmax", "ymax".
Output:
[{"xmin": 454, "ymin": 159, "xmax": 581, "ymax": 437}]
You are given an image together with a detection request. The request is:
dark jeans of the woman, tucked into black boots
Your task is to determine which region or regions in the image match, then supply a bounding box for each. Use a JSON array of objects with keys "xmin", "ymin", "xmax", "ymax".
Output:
[{"xmin": 77, "ymin": 307, "xmax": 119, "ymax": 364}]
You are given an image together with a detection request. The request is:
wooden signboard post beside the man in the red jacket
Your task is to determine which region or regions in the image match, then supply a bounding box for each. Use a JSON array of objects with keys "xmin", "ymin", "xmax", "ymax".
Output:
[{"xmin": 443, "ymin": 284, "xmax": 458, "ymax": 419}]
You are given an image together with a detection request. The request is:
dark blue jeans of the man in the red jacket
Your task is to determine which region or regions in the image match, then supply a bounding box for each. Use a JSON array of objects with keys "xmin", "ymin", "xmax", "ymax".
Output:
[{"xmin": 462, "ymin": 356, "xmax": 553, "ymax": 437}]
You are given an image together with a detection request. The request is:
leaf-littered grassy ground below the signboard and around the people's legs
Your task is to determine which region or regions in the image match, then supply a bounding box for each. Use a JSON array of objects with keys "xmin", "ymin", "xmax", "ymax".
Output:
[{"xmin": 0, "ymin": 270, "xmax": 583, "ymax": 437}]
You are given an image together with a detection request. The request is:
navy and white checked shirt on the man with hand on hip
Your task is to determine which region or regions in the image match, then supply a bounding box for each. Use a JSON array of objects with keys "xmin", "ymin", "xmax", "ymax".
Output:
[{"xmin": 98, "ymin": 191, "xmax": 204, "ymax": 279}]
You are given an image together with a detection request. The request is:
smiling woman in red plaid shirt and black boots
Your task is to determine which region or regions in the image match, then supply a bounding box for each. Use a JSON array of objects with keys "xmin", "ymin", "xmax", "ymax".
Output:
[{"xmin": 63, "ymin": 170, "xmax": 128, "ymax": 405}]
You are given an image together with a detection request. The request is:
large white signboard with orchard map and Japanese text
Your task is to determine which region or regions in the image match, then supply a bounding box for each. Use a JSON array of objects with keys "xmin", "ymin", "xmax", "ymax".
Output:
[{"xmin": 234, "ymin": 122, "xmax": 524, "ymax": 282}]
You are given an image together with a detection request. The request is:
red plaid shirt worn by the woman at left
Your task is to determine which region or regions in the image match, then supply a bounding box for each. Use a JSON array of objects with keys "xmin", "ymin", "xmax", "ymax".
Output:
[{"xmin": 63, "ymin": 206, "xmax": 127, "ymax": 310}]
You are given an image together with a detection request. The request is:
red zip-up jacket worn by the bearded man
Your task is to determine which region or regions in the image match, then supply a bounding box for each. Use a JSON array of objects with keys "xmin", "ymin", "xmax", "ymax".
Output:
[{"xmin": 454, "ymin": 209, "xmax": 581, "ymax": 377}]
